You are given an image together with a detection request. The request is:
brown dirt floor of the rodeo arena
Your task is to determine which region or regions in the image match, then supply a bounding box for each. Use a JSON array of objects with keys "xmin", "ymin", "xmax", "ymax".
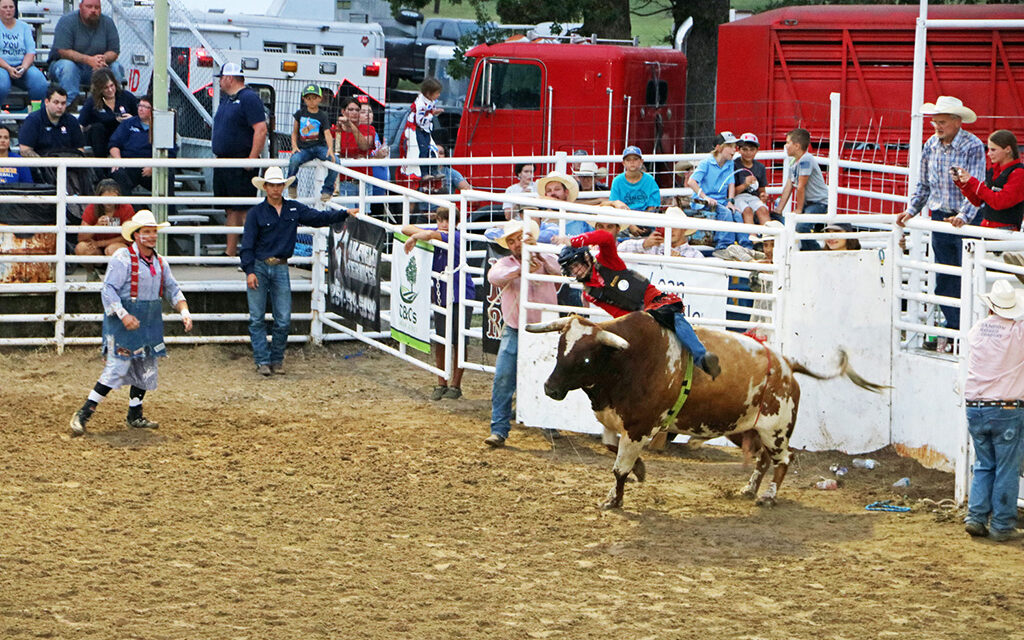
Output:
[{"xmin": 0, "ymin": 345, "xmax": 1024, "ymax": 640}]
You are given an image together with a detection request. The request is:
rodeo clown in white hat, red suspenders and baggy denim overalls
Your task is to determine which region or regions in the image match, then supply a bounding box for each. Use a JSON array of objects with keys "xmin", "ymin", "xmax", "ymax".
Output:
[{"xmin": 71, "ymin": 209, "xmax": 191, "ymax": 436}]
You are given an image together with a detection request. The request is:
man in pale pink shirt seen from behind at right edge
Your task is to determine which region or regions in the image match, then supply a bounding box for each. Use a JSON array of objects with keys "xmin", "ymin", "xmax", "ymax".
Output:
[{"xmin": 964, "ymin": 280, "xmax": 1024, "ymax": 542}]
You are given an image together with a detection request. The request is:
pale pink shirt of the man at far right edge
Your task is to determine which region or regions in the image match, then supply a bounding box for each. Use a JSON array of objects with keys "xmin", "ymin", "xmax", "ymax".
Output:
[{"xmin": 964, "ymin": 313, "xmax": 1024, "ymax": 400}]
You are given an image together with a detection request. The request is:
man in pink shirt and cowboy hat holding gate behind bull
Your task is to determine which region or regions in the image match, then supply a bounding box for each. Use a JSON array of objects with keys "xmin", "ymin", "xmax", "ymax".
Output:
[{"xmin": 483, "ymin": 220, "xmax": 562, "ymax": 446}]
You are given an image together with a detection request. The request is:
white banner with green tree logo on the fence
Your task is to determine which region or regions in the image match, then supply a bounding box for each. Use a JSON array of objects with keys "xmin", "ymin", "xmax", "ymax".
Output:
[{"xmin": 391, "ymin": 233, "xmax": 434, "ymax": 353}]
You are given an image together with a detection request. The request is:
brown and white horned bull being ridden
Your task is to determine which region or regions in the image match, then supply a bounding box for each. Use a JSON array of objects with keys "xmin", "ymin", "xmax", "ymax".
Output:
[{"xmin": 526, "ymin": 312, "xmax": 884, "ymax": 509}]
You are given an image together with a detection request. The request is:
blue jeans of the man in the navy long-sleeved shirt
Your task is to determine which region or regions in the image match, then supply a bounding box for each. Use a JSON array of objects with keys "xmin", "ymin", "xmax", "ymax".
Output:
[{"xmin": 246, "ymin": 260, "xmax": 292, "ymax": 367}]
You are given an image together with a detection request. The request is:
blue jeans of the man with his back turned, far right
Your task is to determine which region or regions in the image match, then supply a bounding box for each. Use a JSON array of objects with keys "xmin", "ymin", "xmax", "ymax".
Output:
[{"xmin": 966, "ymin": 407, "xmax": 1024, "ymax": 531}]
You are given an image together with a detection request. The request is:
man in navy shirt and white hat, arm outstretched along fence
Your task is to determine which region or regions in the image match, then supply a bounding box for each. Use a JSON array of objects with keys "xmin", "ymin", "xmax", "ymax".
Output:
[{"xmin": 239, "ymin": 167, "xmax": 354, "ymax": 376}]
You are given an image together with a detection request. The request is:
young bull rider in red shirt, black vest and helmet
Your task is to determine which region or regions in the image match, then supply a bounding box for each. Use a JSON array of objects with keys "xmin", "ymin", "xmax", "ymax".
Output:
[{"xmin": 558, "ymin": 222, "xmax": 722, "ymax": 379}]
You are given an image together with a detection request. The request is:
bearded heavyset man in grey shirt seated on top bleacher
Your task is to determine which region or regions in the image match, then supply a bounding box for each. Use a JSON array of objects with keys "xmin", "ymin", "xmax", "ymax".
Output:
[{"xmin": 49, "ymin": 0, "xmax": 125, "ymax": 102}]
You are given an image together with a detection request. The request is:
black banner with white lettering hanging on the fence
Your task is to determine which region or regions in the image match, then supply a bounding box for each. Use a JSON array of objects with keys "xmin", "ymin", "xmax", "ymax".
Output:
[{"xmin": 327, "ymin": 217, "xmax": 387, "ymax": 331}]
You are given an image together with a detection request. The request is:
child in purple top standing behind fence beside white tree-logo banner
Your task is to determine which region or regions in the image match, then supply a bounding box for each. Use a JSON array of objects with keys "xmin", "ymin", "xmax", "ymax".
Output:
[{"xmin": 401, "ymin": 207, "xmax": 476, "ymax": 400}]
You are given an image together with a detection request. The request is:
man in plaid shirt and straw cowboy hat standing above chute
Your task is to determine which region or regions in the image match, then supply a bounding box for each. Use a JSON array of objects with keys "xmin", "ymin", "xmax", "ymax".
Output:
[{"xmin": 897, "ymin": 95, "xmax": 985, "ymax": 333}]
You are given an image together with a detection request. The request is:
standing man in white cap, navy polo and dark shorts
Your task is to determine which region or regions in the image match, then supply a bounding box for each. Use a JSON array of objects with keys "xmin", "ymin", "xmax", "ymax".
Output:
[{"xmin": 211, "ymin": 62, "xmax": 267, "ymax": 256}]
